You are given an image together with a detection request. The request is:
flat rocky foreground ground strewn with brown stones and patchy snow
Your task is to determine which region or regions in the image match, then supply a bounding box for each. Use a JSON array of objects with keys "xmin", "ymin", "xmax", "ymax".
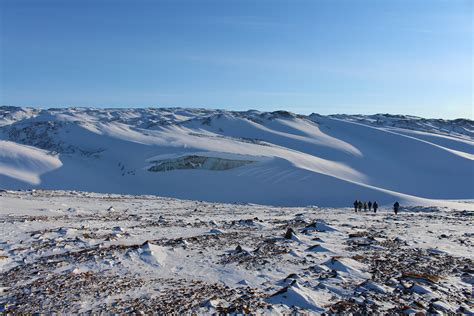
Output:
[{"xmin": 0, "ymin": 191, "xmax": 474, "ymax": 314}]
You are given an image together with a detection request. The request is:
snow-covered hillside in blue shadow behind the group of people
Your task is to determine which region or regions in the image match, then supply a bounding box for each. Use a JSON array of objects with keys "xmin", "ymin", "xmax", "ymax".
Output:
[{"xmin": 0, "ymin": 106, "xmax": 474, "ymax": 206}]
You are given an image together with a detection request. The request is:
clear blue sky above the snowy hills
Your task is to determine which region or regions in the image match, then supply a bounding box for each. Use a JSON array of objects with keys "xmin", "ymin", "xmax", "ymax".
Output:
[{"xmin": 0, "ymin": 0, "xmax": 474, "ymax": 118}]
